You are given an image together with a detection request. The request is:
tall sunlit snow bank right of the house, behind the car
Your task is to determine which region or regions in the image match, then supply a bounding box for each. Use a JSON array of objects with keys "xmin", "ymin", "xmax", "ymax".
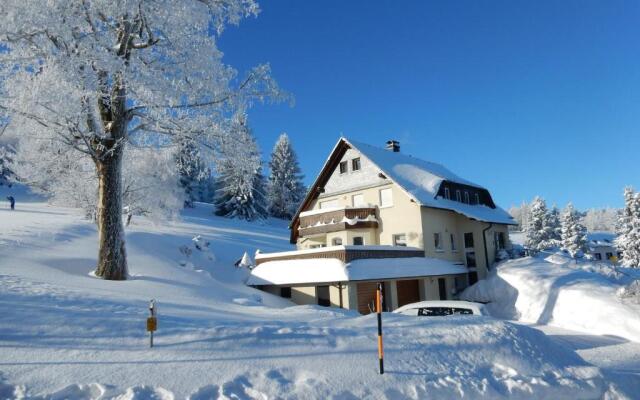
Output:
[{"xmin": 462, "ymin": 256, "xmax": 640, "ymax": 342}]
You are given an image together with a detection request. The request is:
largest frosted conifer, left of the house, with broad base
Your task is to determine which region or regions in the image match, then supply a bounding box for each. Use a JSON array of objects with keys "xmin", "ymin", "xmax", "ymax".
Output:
[{"xmin": 214, "ymin": 115, "xmax": 267, "ymax": 221}]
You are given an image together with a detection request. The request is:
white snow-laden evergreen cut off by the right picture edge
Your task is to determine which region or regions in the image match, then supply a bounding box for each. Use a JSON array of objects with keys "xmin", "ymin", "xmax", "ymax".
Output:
[{"xmin": 616, "ymin": 187, "xmax": 640, "ymax": 268}]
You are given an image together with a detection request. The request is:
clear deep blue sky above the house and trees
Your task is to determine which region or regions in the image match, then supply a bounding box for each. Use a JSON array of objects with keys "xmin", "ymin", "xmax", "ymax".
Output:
[{"xmin": 219, "ymin": 0, "xmax": 640, "ymax": 209}]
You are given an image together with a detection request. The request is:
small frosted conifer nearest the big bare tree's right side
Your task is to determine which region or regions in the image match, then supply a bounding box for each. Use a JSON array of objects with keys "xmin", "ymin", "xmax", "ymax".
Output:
[{"xmin": 175, "ymin": 138, "xmax": 211, "ymax": 208}]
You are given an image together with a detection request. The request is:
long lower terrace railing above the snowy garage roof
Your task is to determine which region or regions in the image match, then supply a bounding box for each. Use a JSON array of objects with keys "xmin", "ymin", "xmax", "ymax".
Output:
[{"xmin": 256, "ymin": 246, "xmax": 424, "ymax": 265}]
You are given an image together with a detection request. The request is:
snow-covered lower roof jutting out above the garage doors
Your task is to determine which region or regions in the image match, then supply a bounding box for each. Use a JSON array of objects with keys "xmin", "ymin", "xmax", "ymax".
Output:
[{"xmin": 247, "ymin": 257, "xmax": 467, "ymax": 285}]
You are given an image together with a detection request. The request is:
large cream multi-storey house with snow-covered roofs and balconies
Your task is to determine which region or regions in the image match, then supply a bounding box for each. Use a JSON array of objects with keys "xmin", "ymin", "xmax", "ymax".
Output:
[{"xmin": 247, "ymin": 138, "xmax": 515, "ymax": 313}]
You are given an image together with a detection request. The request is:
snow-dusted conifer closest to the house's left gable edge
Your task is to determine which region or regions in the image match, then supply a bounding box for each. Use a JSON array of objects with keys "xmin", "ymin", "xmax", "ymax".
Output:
[{"xmin": 267, "ymin": 133, "xmax": 306, "ymax": 219}]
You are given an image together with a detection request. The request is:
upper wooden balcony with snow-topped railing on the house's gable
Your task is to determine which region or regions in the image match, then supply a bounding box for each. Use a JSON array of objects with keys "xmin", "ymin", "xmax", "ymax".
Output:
[{"xmin": 298, "ymin": 207, "xmax": 378, "ymax": 237}]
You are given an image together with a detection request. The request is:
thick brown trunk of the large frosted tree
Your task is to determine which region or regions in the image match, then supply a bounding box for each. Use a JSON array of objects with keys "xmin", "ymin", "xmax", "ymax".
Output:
[{"xmin": 96, "ymin": 146, "xmax": 127, "ymax": 280}]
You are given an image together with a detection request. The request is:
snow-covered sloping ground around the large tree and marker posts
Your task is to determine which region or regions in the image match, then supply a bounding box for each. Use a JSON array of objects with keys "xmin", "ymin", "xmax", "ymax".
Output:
[{"xmin": 0, "ymin": 191, "xmax": 637, "ymax": 399}]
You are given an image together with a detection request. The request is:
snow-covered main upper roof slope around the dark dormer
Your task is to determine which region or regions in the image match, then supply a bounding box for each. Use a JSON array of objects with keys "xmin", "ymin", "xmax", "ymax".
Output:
[{"xmin": 344, "ymin": 139, "xmax": 515, "ymax": 224}]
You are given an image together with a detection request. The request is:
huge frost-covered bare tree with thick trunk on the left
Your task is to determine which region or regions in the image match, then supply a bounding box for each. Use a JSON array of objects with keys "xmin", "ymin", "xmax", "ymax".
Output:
[{"xmin": 0, "ymin": 0, "xmax": 283, "ymax": 280}]
